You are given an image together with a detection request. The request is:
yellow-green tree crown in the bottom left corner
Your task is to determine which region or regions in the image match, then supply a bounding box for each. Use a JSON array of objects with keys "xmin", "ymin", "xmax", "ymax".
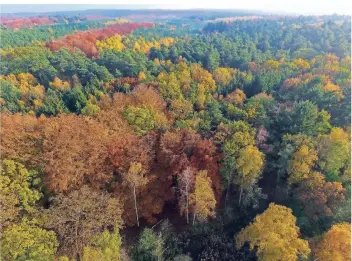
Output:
[{"xmin": 0, "ymin": 218, "xmax": 59, "ymax": 261}]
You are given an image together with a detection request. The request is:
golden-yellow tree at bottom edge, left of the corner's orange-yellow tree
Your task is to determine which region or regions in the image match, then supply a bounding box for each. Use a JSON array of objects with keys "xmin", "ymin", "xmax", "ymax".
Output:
[{"xmin": 236, "ymin": 203, "xmax": 310, "ymax": 261}]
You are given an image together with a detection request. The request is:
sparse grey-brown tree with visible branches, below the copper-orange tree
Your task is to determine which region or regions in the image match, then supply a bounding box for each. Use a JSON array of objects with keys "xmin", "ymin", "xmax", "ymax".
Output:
[{"xmin": 45, "ymin": 186, "xmax": 122, "ymax": 258}]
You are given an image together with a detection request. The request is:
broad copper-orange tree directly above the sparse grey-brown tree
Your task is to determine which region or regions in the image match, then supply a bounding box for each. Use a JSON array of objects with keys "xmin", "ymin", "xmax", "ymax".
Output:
[{"xmin": 43, "ymin": 115, "xmax": 112, "ymax": 192}]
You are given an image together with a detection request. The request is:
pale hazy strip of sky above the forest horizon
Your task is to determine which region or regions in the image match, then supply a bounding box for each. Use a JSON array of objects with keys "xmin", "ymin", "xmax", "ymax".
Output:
[{"xmin": 1, "ymin": 0, "xmax": 352, "ymax": 15}]
